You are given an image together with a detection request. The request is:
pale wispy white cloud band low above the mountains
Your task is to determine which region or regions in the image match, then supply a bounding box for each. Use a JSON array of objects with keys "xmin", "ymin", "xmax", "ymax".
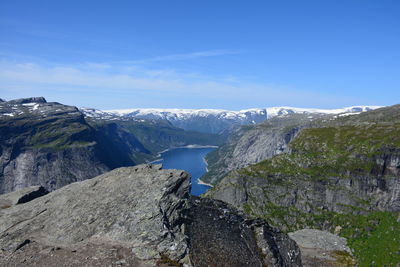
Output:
[{"xmin": 0, "ymin": 58, "xmax": 360, "ymax": 109}]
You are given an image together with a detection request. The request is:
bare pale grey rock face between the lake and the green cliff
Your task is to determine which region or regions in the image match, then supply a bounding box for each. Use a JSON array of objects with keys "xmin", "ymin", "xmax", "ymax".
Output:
[{"xmin": 201, "ymin": 113, "xmax": 331, "ymax": 184}]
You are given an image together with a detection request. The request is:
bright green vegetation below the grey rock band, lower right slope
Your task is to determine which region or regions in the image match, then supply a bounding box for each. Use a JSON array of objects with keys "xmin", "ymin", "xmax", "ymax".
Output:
[{"xmin": 243, "ymin": 198, "xmax": 400, "ymax": 266}]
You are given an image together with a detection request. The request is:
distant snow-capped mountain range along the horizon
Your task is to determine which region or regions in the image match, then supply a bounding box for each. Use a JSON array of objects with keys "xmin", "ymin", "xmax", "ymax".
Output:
[{"xmin": 81, "ymin": 106, "xmax": 379, "ymax": 133}]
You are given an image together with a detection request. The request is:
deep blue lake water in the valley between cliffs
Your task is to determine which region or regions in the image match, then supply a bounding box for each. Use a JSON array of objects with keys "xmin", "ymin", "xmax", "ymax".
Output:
[{"xmin": 156, "ymin": 147, "xmax": 215, "ymax": 196}]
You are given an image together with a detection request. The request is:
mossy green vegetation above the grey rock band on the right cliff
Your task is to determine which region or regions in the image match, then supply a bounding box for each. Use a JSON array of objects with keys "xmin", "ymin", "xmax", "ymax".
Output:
[{"xmin": 241, "ymin": 123, "xmax": 400, "ymax": 180}]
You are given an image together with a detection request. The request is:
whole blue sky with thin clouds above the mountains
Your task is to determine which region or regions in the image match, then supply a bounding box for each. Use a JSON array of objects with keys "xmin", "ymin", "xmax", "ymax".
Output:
[{"xmin": 0, "ymin": 0, "xmax": 400, "ymax": 110}]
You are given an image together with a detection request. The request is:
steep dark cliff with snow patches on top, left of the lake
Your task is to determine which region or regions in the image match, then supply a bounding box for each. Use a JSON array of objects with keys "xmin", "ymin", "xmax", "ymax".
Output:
[{"xmin": 0, "ymin": 98, "xmax": 150, "ymax": 193}]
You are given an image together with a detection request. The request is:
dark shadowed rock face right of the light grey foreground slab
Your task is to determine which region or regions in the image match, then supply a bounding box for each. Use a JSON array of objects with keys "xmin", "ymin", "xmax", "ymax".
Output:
[{"xmin": 187, "ymin": 197, "xmax": 302, "ymax": 267}]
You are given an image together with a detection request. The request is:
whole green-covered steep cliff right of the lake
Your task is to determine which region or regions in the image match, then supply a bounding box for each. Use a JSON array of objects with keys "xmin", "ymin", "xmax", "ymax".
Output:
[{"xmin": 208, "ymin": 105, "xmax": 400, "ymax": 266}]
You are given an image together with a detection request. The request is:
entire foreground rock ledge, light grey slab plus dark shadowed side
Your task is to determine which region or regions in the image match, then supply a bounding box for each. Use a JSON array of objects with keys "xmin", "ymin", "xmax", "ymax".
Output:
[{"xmin": 0, "ymin": 165, "xmax": 301, "ymax": 266}]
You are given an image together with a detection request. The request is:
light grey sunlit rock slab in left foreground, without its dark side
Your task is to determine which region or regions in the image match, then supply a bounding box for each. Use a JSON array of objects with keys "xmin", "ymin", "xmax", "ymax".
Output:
[{"xmin": 0, "ymin": 165, "xmax": 190, "ymax": 266}]
